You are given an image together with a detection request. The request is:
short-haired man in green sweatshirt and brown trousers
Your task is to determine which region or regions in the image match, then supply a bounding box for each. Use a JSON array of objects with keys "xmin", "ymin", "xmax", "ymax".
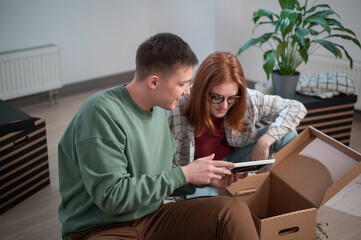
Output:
[{"xmin": 58, "ymin": 33, "xmax": 257, "ymax": 239}]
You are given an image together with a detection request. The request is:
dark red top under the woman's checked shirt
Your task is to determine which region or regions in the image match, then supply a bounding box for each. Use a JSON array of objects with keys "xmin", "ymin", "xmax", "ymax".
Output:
[{"xmin": 194, "ymin": 117, "xmax": 233, "ymax": 160}]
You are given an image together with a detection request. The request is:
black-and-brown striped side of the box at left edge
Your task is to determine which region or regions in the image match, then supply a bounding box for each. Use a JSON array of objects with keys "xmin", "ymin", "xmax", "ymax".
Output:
[{"xmin": 0, "ymin": 118, "xmax": 50, "ymax": 214}]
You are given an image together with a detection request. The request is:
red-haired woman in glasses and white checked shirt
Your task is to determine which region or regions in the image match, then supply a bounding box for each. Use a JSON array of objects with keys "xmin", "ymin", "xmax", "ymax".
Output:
[{"xmin": 168, "ymin": 52, "xmax": 307, "ymax": 197}]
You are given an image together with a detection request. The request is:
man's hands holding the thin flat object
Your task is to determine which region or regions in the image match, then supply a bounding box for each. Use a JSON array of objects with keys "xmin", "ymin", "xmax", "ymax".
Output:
[{"xmin": 182, "ymin": 154, "xmax": 233, "ymax": 186}]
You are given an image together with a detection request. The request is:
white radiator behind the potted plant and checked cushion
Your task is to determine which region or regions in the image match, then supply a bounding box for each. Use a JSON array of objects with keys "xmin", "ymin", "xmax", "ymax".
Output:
[{"xmin": 298, "ymin": 54, "xmax": 361, "ymax": 110}]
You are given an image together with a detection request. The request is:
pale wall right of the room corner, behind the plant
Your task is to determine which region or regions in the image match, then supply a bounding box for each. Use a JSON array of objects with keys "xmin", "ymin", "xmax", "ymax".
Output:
[{"xmin": 215, "ymin": 0, "xmax": 361, "ymax": 82}]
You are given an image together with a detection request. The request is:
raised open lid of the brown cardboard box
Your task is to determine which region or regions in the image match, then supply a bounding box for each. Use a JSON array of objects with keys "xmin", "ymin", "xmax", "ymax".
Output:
[{"xmin": 270, "ymin": 127, "xmax": 361, "ymax": 215}]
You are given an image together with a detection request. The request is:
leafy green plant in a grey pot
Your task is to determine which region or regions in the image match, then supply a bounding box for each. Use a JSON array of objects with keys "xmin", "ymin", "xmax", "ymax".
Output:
[{"xmin": 236, "ymin": 0, "xmax": 361, "ymax": 98}]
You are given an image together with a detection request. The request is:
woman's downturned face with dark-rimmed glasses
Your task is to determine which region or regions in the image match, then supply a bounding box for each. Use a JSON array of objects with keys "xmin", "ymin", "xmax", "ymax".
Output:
[{"xmin": 209, "ymin": 82, "xmax": 238, "ymax": 118}]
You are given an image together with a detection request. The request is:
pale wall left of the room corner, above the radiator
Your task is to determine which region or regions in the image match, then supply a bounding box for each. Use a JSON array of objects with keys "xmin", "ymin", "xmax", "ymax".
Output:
[{"xmin": 0, "ymin": 0, "xmax": 215, "ymax": 84}]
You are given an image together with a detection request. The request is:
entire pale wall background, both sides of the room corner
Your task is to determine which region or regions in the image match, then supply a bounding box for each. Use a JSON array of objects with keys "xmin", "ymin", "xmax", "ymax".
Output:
[{"xmin": 0, "ymin": 0, "xmax": 361, "ymax": 84}]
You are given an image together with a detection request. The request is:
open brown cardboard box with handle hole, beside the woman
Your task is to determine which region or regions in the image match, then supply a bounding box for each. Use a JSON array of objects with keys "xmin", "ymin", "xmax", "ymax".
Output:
[{"xmin": 227, "ymin": 127, "xmax": 361, "ymax": 240}]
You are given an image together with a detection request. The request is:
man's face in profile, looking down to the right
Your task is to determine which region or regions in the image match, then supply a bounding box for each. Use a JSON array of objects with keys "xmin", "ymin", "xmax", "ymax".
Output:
[{"xmin": 158, "ymin": 67, "xmax": 193, "ymax": 110}]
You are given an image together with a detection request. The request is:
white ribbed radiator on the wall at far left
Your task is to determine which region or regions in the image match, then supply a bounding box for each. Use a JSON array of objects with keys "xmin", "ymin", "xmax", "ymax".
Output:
[{"xmin": 0, "ymin": 45, "xmax": 63, "ymax": 100}]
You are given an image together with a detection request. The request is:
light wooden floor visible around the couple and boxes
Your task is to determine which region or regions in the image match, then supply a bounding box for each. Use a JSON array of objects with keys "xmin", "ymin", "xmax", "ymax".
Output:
[{"xmin": 0, "ymin": 90, "xmax": 361, "ymax": 240}]
